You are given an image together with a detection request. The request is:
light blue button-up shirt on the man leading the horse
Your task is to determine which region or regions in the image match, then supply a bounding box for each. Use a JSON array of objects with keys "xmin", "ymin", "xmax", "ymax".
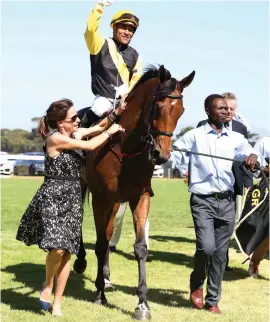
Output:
[{"xmin": 170, "ymin": 123, "xmax": 258, "ymax": 195}]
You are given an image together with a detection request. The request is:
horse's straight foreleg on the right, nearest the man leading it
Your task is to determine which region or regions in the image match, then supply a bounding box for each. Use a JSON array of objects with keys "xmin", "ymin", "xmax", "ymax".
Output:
[{"xmin": 130, "ymin": 192, "xmax": 151, "ymax": 320}]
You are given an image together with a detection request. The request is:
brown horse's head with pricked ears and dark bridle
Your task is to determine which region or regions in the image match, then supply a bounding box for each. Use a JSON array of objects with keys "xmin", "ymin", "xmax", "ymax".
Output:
[{"xmin": 146, "ymin": 65, "xmax": 195, "ymax": 164}]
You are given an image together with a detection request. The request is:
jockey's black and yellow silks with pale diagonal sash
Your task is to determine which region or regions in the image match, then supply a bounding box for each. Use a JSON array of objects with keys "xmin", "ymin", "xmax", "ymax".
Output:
[{"xmin": 84, "ymin": 4, "xmax": 142, "ymax": 98}]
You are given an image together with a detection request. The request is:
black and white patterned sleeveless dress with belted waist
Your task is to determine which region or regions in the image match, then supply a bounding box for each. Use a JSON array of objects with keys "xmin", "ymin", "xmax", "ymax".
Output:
[{"xmin": 16, "ymin": 132, "xmax": 83, "ymax": 254}]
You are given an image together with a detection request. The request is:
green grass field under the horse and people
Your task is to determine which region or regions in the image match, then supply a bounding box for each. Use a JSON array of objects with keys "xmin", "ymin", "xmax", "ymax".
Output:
[{"xmin": 1, "ymin": 178, "xmax": 269, "ymax": 322}]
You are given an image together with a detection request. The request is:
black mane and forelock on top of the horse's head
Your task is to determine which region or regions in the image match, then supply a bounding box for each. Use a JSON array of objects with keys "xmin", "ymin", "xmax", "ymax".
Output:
[{"xmin": 130, "ymin": 65, "xmax": 173, "ymax": 96}]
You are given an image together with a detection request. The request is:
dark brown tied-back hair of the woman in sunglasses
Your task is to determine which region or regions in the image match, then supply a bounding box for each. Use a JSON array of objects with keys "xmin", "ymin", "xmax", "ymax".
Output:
[{"xmin": 38, "ymin": 98, "xmax": 73, "ymax": 138}]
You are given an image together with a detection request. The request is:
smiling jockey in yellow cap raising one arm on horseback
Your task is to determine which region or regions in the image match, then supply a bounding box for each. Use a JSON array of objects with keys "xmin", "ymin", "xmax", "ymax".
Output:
[{"xmin": 81, "ymin": 0, "xmax": 142, "ymax": 125}]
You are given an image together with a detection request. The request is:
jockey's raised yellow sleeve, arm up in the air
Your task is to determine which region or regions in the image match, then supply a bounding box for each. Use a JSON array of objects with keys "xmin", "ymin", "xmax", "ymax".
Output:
[{"xmin": 84, "ymin": 3, "xmax": 105, "ymax": 55}]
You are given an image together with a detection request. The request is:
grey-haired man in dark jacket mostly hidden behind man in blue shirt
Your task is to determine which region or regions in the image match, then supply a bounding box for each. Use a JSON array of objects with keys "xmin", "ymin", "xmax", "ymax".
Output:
[{"xmin": 197, "ymin": 93, "xmax": 253, "ymax": 272}]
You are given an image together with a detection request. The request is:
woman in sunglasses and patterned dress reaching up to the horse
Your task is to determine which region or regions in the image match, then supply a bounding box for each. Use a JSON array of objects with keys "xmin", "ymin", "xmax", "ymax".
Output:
[{"xmin": 16, "ymin": 99, "xmax": 124, "ymax": 316}]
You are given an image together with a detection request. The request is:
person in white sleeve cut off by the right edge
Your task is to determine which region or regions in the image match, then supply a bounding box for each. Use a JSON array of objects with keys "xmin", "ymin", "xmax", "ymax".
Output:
[{"xmin": 248, "ymin": 136, "xmax": 270, "ymax": 278}]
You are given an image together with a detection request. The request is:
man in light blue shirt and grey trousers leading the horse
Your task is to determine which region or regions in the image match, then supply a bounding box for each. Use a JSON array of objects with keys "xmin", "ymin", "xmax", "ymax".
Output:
[{"xmin": 171, "ymin": 94, "xmax": 257, "ymax": 313}]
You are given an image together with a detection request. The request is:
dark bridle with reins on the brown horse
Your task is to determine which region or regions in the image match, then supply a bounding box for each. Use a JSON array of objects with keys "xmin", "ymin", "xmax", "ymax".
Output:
[{"xmin": 110, "ymin": 82, "xmax": 183, "ymax": 159}]
